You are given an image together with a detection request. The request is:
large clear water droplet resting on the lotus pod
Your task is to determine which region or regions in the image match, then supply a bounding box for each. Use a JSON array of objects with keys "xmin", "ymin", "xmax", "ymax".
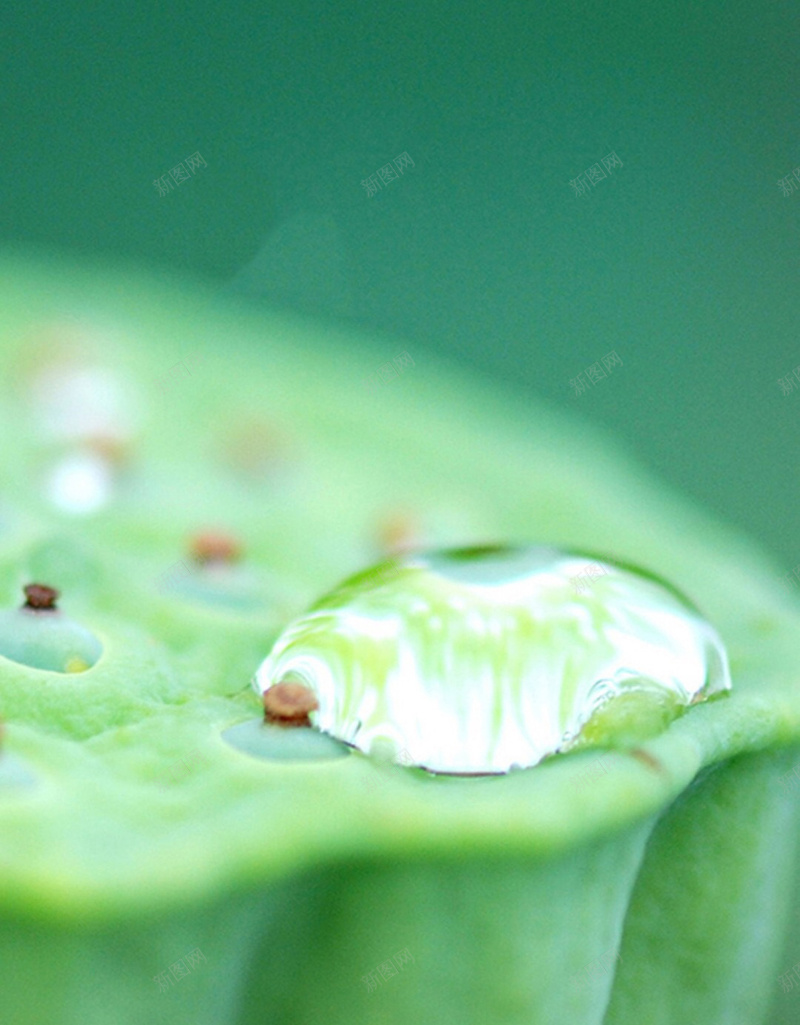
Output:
[{"xmin": 253, "ymin": 545, "xmax": 730, "ymax": 773}]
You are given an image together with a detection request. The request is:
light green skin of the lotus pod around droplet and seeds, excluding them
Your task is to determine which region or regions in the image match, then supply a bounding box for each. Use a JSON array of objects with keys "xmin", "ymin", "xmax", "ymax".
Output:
[{"xmin": 0, "ymin": 250, "xmax": 800, "ymax": 1025}]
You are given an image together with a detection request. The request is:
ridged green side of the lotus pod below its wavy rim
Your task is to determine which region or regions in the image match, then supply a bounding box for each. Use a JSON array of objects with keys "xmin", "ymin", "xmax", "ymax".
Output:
[{"xmin": 0, "ymin": 749, "xmax": 798, "ymax": 1025}]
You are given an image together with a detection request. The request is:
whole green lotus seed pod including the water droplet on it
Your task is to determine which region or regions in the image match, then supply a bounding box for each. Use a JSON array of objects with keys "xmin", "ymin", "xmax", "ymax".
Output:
[{"xmin": 0, "ymin": 258, "xmax": 800, "ymax": 1025}]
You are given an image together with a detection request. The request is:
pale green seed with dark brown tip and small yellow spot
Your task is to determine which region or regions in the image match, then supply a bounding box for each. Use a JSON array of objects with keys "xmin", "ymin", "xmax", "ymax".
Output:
[{"xmin": 0, "ymin": 583, "xmax": 103, "ymax": 673}]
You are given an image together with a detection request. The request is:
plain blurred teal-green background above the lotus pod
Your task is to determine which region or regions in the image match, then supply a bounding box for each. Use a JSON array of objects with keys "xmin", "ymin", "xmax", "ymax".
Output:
[{"xmin": 0, "ymin": 0, "xmax": 800, "ymax": 571}]
